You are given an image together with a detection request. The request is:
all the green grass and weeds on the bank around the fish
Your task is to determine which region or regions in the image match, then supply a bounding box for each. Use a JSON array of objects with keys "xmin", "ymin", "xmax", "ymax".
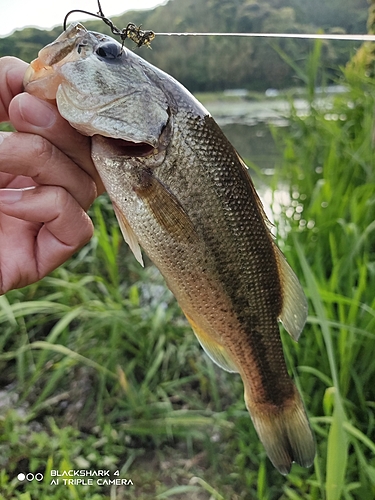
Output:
[{"xmin": 0, "ymin": 53, "xmax": 375, "ymax": 500}]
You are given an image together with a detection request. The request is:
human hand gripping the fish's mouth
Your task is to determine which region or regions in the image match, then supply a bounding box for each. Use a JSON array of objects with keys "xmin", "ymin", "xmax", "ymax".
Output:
[{"xmin": 0, "ymin": 57, "xmax": 104, "ymax": 295}]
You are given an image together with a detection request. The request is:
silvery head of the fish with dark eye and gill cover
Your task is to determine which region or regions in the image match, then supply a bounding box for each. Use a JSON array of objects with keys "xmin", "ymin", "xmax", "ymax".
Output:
[{"xmin": 24, "ymin": 23, "xmax": 174, "ymax": 152}]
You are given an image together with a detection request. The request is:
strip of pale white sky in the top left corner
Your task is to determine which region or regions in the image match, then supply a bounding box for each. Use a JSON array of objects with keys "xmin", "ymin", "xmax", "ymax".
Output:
[{"xmin": 0, "ymin": 0, "xmax": 165, "ymax": 37}]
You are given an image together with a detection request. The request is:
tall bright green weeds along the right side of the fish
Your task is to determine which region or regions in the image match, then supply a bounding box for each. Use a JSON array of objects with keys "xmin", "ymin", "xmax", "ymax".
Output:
[{"xmin": 274, "ymin": 48, "xmax": 375, "ymax": 500}]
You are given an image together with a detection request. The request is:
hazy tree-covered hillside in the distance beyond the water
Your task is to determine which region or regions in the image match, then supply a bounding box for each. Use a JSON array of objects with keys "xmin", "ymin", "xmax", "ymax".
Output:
[{"xmin": 0, "ymin": 0, "xmax": 375, "ymax": 91}]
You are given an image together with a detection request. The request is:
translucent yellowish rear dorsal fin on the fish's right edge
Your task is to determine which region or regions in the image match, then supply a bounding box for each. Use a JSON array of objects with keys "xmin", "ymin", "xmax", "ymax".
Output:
[{"xmin": 274, "ymin": 245, "xmax": 307, "ymax": 341}]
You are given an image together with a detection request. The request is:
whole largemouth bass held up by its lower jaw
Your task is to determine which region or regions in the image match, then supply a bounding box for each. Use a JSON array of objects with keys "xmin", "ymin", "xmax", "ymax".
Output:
[{"xmin": 25, "ymin": 23, "xmax": 315, "ymax": 474}]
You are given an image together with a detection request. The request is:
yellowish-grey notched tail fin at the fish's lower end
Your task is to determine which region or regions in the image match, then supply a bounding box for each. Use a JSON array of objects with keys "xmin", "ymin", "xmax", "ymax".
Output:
[{"xmin": 245, "ymin": 387, "xmax": 315, "ymax": 475}]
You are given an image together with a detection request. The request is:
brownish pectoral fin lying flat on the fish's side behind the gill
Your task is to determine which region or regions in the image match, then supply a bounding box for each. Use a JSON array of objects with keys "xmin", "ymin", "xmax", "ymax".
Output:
[{"xmin": 134, "ymin": 174, "xmax": 198, "ymax": 243}]
